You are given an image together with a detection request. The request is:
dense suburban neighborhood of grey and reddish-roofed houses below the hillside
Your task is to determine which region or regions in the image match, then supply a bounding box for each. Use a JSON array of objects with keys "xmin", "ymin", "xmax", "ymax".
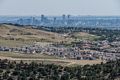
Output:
[{"xmin": 0, "ymin": 41, "xmax": 120, "ymax": 61}]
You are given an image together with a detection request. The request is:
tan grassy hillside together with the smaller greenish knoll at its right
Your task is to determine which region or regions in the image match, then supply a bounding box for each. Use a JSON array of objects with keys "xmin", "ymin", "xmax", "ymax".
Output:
[{"xmin": 0, "ymin": 24, "xmax": 99, "ymax": 47}]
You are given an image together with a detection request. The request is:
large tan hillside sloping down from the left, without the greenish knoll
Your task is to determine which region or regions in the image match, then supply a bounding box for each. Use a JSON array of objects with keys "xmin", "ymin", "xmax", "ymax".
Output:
[{"xmin": 0, "ymin": 24, "xmax": 66, "ymax": 46}]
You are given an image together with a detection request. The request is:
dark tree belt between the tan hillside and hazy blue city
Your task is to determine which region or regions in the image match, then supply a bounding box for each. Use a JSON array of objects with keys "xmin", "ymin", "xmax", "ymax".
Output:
[{"xmin": 38, "ymin": 26, "xmax": 120, "ymax": 42}]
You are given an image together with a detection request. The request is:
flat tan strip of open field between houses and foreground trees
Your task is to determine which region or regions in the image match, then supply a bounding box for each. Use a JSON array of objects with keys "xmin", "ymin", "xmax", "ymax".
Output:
[{"xmin": 0, "ymin": 52, "xmax": 102, "ymax": 66}]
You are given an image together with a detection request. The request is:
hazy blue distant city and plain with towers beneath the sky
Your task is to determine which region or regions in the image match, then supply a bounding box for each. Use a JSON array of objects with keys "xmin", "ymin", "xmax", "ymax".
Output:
[{"xmin": 0, "ymin": 15, "xmax": 120, "ymax": 28}]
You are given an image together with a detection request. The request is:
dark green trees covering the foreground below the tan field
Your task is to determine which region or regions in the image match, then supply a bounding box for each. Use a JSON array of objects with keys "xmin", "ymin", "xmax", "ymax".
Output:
[{"xmin": 0, "ymin": 60, "xmax": 120, "ymax": 80}]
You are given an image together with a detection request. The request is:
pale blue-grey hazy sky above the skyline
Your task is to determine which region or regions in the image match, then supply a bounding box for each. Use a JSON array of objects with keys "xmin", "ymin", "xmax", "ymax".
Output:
[{"xmin": 0, "ymin": 0, "xmax": 120, "ymax": 15}]
